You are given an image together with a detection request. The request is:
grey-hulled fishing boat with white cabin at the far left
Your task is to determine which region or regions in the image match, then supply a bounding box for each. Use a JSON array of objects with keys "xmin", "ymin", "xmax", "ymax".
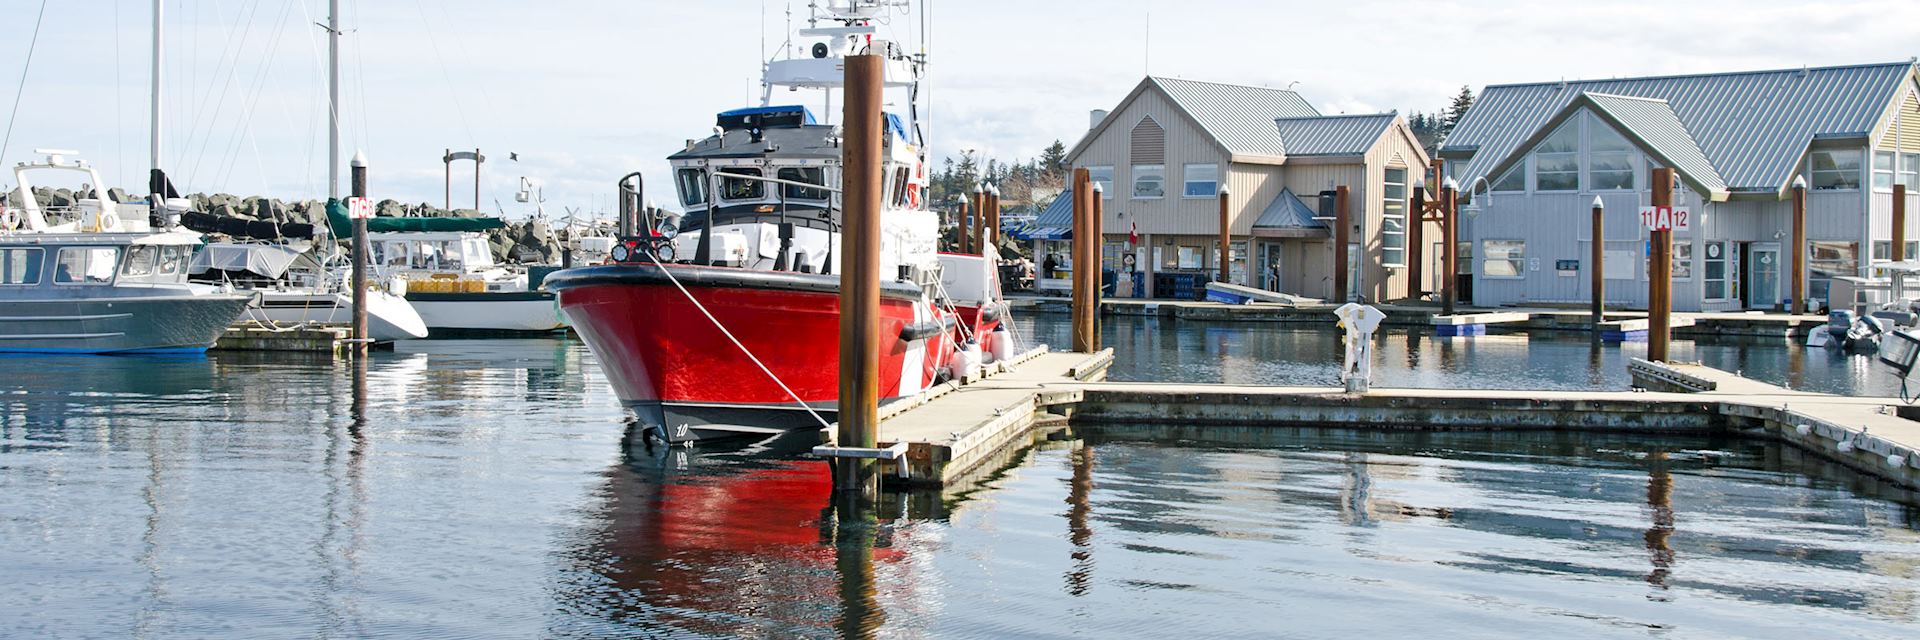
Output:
[{"xmin": 0, "ymin": 152, "xmax": 253, "ymax": 354}]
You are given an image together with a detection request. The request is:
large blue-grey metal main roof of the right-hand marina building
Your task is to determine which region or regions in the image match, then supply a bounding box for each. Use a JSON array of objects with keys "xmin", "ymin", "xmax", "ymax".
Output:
[{"xmin": 1440, "ymin": 62, "xmax": 1914, "ymax": 192}]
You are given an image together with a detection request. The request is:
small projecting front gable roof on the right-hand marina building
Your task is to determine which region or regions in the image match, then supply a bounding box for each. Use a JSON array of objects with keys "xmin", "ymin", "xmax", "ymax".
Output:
[{"xmin": 1486, "ymin": 92, "xmax": 1728, "ymax": 200}]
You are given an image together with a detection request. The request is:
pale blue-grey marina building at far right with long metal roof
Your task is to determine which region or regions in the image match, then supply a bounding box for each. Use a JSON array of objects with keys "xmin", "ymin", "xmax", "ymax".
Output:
[{"xmin": 1434, "ymin": 60, "xmax": 1920, "ymax": 311}]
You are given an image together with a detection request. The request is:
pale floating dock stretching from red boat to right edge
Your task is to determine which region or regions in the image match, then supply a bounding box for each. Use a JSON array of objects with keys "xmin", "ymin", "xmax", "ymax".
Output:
[{"xmin": 856, "ymin": 350, "xmax": 1920, "ymax": 490}]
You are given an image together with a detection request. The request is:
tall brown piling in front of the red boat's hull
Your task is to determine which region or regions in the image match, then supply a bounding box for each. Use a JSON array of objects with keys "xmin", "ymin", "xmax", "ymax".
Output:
[{"xmin": 833, "ymin": 56, "xmax": 885, "ymax": 494}]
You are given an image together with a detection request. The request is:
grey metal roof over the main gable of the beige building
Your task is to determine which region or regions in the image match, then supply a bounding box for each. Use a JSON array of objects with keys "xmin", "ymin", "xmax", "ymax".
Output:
[{"xmin": 1068, "ymin": 75, "xmax": 1319, "ymax": 158}]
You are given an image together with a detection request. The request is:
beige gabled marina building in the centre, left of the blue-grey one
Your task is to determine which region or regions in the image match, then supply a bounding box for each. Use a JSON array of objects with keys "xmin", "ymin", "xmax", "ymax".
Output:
[{"xmin": 1059, "ymin": 77, "xmax": 1438, "ymax": 300}]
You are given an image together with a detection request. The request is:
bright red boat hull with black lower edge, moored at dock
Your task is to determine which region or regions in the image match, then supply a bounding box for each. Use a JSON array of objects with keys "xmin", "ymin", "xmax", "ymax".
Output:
[{"xmin": 545, "ymin": 265, "xmax": 952, "ymax": 442}]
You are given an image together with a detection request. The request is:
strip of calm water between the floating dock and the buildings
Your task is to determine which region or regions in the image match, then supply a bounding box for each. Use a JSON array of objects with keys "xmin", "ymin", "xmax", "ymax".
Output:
[{"xmin": 1018, "ymin": 313, "xmax": 1899, "ymax": 396}]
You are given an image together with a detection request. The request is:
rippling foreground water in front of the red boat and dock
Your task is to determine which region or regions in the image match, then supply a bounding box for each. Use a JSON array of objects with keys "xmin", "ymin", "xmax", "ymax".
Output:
[{"xmin": 0, "ymin": 329, "xmax": 1920, "ymax": 640}]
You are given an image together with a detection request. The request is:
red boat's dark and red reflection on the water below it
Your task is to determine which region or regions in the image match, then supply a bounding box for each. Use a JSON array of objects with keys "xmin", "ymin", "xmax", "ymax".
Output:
[{"xmin": 555, "ymin": 431, "xmax": 924, "ymax": 638}]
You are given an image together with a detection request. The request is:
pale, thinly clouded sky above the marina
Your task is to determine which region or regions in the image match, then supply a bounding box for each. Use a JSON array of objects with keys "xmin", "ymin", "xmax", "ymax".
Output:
[{"xmin": 0, "ymin": 0, "xmax": 1920, "ymax": 217}]
